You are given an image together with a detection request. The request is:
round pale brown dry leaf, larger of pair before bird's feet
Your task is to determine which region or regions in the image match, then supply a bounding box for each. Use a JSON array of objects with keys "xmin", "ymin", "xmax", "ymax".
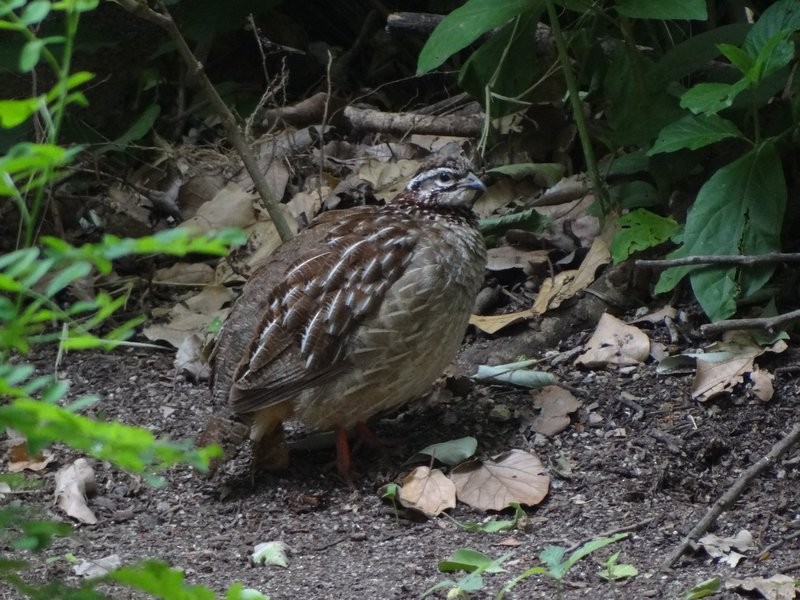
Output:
[{"xmin": 450, "ymin": 450, "xmax": 550, "ymax": 510}]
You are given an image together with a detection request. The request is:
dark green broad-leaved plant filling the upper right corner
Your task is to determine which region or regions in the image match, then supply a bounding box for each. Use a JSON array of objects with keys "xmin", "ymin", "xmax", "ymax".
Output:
[{"xmin": 418, "ymin": 0, "xmax": 800, "ymax": 320}]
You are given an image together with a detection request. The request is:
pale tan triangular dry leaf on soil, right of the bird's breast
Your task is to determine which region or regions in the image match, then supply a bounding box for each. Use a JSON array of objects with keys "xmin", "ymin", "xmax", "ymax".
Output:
[{"xmin": 575, "ymin": 313, "xmax": 650, "ymax": 369}]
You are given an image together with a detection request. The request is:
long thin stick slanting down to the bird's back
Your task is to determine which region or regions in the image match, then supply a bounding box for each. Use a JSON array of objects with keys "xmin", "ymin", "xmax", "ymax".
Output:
[{"xmin": 117, "ymin": 0, "xmax": 294, "ymax": 242}]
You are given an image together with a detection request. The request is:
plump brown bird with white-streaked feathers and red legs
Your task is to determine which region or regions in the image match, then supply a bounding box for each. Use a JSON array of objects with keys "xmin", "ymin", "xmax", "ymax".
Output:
[{"xmin": 212, "ymin": 156, "xmax": 486, "ymax": 477}]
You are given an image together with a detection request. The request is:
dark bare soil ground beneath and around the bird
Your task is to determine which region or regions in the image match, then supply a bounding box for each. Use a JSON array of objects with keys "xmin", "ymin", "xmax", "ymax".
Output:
[{"xmin": 6, "ymin": 316, "xmax": 800, "ymax": 600}]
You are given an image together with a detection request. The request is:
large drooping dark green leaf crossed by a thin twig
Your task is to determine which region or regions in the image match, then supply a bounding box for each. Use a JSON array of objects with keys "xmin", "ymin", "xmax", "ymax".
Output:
[{"xmin": 655, "ymin": 140, "xmax": 787, "ymax": 321}]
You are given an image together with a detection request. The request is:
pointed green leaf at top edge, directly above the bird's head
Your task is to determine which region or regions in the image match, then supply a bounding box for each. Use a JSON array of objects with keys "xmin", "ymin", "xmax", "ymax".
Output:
[{"xmin": 417, "ymin": 0, "xmax": 542, "ymax": 75}]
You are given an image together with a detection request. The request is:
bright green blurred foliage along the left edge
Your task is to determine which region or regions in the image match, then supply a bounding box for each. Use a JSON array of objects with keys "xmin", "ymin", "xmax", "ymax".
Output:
[{"xmin": 0, "ymin": 0, "xmax": 256, "ymax": 600}]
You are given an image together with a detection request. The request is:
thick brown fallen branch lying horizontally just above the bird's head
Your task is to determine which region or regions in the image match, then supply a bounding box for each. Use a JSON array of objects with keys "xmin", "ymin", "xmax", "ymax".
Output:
[{"xmin": 344, "ymin": 106, "xmax": 483, "ymax": 137}]
